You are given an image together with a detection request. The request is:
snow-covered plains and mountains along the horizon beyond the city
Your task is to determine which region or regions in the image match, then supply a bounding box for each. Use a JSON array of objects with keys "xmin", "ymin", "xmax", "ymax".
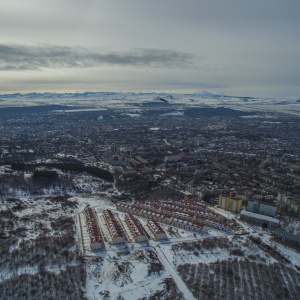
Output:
[{"xmin": 0, "ymin": 91, "xmax": 300, "ymax": 116}]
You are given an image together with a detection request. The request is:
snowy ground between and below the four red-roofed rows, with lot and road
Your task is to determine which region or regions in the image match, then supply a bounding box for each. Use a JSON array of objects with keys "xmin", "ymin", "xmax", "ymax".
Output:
[{"xmin": 72, "ymin": 195, "xmax": 234, "ymax": 300}]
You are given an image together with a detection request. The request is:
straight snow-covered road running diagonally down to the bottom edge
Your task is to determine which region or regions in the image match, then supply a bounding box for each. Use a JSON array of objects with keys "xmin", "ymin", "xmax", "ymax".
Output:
[{"xmin": 150, "ymin": 241, "xmax": 195, "ymax": 300}]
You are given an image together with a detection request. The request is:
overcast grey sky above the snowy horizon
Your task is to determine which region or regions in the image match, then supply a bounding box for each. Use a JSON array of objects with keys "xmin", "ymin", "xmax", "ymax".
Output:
[{"xmin": 0, "ymin": 0, "xmax": 300, "ymax": 97}]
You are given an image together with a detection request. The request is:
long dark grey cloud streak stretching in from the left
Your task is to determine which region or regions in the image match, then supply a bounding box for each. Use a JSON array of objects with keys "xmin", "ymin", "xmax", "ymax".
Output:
[{"xmin": 0, "ymin": 44, "xmax": 194, "ymax": 70}]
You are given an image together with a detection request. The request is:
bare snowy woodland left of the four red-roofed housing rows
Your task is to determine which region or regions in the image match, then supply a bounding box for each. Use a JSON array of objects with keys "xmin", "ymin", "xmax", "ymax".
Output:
[{"xmin": 0, "ymin": 197, "xmax": 86, "ymax": 300}]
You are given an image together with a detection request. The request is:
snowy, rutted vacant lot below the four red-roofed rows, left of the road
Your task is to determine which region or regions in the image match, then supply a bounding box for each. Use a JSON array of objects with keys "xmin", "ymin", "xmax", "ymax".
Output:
[{"xmin": 87, "ymin": 251, "xmax": 170, "ymax": 300}]
